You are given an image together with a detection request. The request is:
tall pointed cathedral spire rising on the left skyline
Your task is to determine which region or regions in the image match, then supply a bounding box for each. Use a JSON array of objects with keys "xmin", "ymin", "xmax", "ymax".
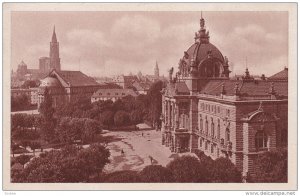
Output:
[{"xmin": 49, "ymin": 26, "xmax": 60, "ymax": 70}]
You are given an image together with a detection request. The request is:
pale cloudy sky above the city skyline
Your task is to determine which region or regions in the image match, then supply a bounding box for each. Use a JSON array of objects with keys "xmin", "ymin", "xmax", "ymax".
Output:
[{"xmin": 11, "ymin": 11, "xmax": 288, "ymax": 77}]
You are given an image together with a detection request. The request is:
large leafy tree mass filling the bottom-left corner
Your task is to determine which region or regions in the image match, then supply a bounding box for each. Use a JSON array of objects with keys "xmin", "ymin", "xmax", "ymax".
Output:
[{"xmin": 12, "ymin": 144, "xmax": 110, "ymax": 182}]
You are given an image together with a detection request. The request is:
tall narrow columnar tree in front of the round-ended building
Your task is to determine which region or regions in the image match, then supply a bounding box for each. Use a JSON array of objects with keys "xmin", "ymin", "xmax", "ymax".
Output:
[{"xmin": 40, "ymin": 87, "xmax": 56, "ymax": 142}]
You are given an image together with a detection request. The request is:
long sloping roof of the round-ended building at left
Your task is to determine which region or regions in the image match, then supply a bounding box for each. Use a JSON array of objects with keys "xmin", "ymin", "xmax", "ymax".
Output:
[{"xmin": 49, "ymin": 70, "xmax": 99, "ymax": 87}]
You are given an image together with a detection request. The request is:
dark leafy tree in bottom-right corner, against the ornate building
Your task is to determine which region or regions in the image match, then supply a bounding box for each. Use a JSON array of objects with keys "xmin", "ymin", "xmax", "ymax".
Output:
[{"xmin": 250, "ymin": 149, "xmax": 288, "ymax": 183}]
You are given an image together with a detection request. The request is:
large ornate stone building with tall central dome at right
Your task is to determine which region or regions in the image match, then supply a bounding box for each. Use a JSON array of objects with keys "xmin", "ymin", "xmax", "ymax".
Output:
[{"xmin": 161, "ymin": 17, "xmax": 288, "ymax": 176}]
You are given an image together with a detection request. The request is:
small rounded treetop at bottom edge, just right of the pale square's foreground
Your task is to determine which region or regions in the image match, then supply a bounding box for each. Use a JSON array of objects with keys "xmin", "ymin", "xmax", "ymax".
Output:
[{"xmin": 140, "ymin": 165, "xmax": 175, "ymax": 182}]
